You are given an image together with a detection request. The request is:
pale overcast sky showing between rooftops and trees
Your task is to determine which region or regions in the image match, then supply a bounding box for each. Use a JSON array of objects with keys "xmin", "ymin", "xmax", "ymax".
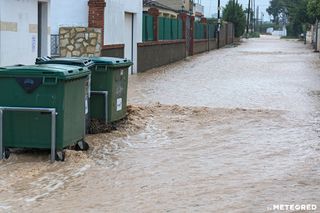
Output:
[{"xmin": 199, "ymin": 0, "xmax": 270, "ymax": 21}]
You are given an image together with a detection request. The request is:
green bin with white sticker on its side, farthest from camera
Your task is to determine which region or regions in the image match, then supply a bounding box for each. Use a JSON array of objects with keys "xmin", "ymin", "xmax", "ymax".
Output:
[{"xmin": 90, "ymin": 57, "xmax": 132, "ymax": 122}]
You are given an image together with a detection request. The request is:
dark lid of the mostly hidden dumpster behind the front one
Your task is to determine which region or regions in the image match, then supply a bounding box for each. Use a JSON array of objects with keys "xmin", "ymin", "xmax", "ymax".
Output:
[{"xmin": 36, "ymin": 56, "xmax": 94, "ymax": 68}]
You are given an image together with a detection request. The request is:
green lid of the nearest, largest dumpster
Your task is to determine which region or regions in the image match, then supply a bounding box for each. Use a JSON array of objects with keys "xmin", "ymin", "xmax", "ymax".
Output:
[{"xmin": 0, "ymin": 64, "xmax": 90, "ymax": 80}]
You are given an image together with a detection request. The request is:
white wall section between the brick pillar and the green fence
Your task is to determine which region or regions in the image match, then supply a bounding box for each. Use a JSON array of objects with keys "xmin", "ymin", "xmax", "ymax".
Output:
[{"xmin": 104, "ymin": 0, "xmax": 143, "ymax": 73}]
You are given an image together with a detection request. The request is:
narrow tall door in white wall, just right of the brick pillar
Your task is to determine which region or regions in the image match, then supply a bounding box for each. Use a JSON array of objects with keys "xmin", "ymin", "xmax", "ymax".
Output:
[{"xmin": 124, "ymin": 13, "xmax": 135, "ymax": 74}]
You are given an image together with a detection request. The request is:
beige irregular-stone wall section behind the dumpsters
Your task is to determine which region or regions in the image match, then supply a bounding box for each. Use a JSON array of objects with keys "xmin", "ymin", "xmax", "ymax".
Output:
[{"xmin": 59, "ymin": 27, "xmax": 102, "ymax": 57}]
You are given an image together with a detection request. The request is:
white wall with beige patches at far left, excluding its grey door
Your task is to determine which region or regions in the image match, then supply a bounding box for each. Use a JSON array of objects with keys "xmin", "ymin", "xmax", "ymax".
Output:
[{"xmin": 0, "ymin": 0, "xmax": 50, "ymax": 66}]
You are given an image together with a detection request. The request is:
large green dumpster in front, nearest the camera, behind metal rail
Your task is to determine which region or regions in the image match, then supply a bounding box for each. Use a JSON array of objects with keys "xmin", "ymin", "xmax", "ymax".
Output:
[{"xmin": 0, "ymin": 65, "xmax": 90, "ymax": 161}]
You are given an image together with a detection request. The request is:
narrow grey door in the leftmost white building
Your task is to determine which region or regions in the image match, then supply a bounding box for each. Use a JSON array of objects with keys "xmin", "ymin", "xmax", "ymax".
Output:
[{"xmin": 38, "ymin": 2, "xmax": 48, "ymax": 57}]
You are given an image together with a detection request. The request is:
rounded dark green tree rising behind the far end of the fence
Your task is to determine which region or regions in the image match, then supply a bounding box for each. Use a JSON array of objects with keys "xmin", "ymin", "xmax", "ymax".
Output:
[{"xmin": 222, "ymin": 0, "xmax": 246, "ymax": 37}]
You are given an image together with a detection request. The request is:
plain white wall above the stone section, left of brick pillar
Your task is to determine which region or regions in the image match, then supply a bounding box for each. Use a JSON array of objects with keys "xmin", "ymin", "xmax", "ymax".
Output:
[{"xmin": 51, "ymin": 0, "xmax": 88, "ymax": 34}]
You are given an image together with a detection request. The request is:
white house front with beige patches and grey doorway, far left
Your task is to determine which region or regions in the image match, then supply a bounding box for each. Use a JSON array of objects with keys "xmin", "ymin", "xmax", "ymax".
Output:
[{"xmin": 0, "ymin": 0, "xmax": 50, "ymax": 66}]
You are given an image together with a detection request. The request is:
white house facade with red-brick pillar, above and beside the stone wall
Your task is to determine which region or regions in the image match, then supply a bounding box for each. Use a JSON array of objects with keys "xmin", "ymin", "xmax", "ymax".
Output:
[{"xmin": 51, "ymin": 0, "xmax": 143, "ymax": 73}]
